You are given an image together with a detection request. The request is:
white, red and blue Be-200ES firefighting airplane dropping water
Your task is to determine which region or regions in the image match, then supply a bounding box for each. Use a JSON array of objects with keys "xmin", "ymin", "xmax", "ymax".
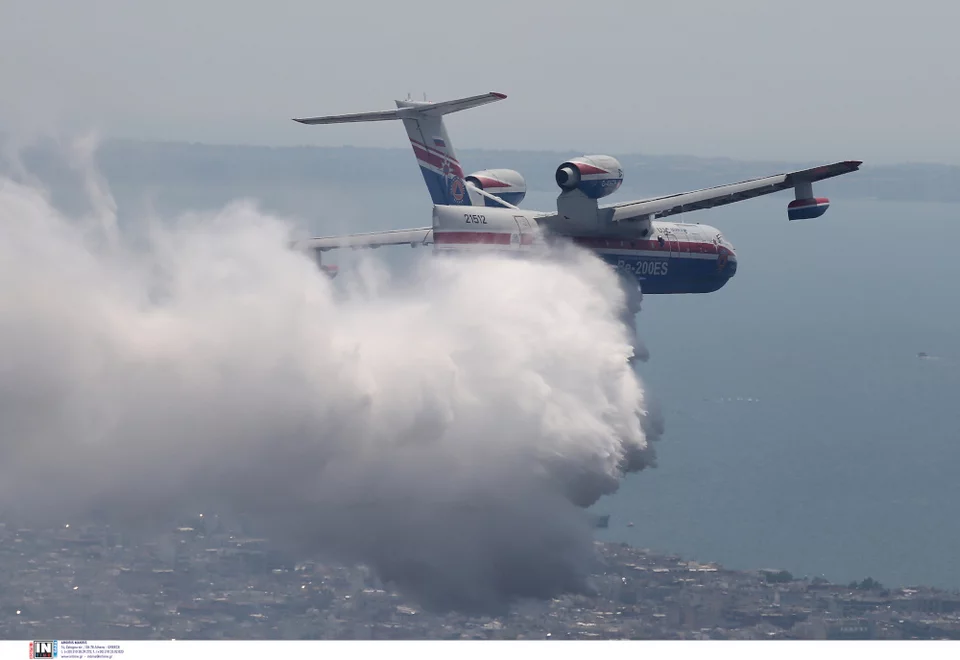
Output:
[{"xmin": 286, "ymin": 92, "xmax": 861, "ymax": 294}]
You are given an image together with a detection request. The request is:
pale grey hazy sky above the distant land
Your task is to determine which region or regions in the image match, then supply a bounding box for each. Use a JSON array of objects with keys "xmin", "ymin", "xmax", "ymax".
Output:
[{"xmin": 0, "ymin": 0, "xmax": 960, "ymax": 164}]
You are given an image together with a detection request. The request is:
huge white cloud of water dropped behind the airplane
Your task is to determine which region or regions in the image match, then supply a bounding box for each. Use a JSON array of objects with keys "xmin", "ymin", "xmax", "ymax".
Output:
[{"xmin": 0, "ymin": 148, "xmax": 661, "ymax": 609}]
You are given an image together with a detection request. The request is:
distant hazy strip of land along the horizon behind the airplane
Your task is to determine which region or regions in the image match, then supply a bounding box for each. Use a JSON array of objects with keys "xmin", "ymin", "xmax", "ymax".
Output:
[{"xmin": 0, "ymin": 136, "xmax": 960, "ymax": 203}]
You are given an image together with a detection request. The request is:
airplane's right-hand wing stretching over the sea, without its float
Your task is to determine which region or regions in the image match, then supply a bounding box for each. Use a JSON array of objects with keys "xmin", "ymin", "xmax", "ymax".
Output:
[{"xmin": 602, "ymin": 160, "xmax": 861, "ymax": 222}]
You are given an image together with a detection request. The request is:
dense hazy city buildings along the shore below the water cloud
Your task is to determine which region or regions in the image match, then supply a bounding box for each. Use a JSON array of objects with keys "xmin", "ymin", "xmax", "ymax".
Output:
[{"xmin": 0, "ymin": 516, "xmax": 960, "ymax": 639}]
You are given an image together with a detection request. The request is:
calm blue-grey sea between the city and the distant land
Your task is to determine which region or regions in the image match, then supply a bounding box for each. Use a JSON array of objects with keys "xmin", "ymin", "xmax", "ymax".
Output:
[{"xmin": 54, "ymin": 168, "xmax": 960, "ymax": 589}]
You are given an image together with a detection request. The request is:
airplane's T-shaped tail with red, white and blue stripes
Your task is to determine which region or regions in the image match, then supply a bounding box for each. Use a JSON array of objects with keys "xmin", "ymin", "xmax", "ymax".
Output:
[{"xmin": 294, "ymin": 92, "xmax": 508, "ymax": 206}]
